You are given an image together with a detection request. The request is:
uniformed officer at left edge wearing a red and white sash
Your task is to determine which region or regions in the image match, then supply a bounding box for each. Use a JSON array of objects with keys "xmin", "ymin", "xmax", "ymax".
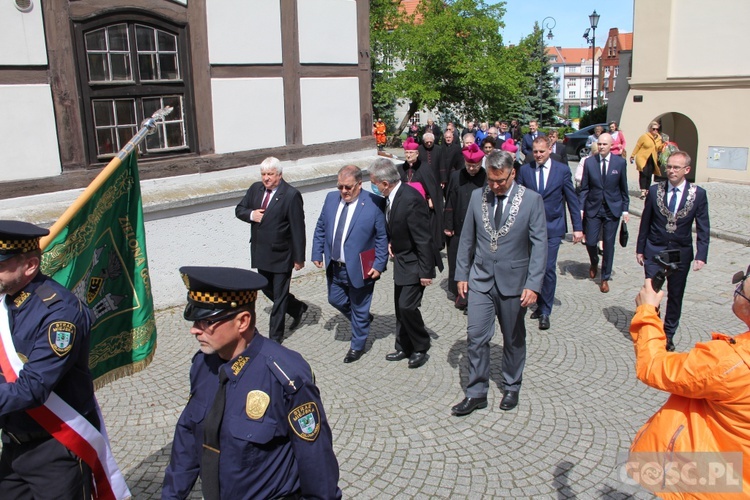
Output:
[{"xmin": 0, "ymin": 221, "xmax": 99, "ymax": 500}]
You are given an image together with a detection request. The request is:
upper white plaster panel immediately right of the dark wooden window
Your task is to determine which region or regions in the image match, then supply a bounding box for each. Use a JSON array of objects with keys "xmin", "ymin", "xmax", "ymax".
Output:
[{"xmin": 206, "ymin": 0, "xmax": 281, "ymax": 64}]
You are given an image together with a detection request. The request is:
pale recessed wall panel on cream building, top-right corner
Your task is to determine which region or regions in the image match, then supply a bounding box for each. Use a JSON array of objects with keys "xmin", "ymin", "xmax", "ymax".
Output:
[{"xmin": 667, "ymin": 0, "xmax": 750, "ymax": 78}]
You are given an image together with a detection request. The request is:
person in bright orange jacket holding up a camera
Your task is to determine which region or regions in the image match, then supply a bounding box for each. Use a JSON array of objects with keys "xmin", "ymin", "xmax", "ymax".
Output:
[{"xmin": 626, "ymin": 267, "xmax": 750, "ymax": 498}]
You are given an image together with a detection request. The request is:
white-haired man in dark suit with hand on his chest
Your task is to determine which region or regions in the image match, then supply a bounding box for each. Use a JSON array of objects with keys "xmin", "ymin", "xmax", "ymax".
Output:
[{"xmin": 234, "ymin": 156, "xmax": 307, "ymax": 344}]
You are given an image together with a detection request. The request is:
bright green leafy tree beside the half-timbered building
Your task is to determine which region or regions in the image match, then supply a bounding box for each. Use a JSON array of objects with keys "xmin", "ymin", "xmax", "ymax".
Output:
[{"xmin": 370, "ymin": 0, "xmax": 525, "ymax": 135}]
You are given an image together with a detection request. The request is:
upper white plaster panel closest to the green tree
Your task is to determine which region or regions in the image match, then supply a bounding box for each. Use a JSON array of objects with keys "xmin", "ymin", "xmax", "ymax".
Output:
[{"xmin": 297, "ymin": 0, "xmax": 359, "ymax": 64}]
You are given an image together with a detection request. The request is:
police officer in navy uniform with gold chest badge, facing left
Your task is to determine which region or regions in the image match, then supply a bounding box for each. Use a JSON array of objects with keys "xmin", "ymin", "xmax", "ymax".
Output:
[{"xmin": 162, "ymin": 267, "xmax": 341, "ymax": 500}]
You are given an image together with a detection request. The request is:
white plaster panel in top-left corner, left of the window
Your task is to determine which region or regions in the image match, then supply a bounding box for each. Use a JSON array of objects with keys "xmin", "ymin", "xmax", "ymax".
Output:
[{"xmin": 0, "ymin": 0, "xmax": 47, "ymax": 66}]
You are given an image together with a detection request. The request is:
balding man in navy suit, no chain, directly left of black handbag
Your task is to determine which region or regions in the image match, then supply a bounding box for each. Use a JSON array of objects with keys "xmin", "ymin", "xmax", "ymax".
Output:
[{"xmin": 580, "ymin": 134, "xmax": 630, "ymax": 293}]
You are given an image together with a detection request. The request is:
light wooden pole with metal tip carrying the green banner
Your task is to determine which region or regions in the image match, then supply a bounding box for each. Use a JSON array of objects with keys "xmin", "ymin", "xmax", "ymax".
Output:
[{"xmin": 39, "ymin": 106, "xmax": 172, "ymax": 251}]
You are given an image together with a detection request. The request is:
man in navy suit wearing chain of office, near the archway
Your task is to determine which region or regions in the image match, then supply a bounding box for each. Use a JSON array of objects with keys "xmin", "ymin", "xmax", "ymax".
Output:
[{"xmin": 636, "ymin": 151, "xmax": 711, "ymax": 351}]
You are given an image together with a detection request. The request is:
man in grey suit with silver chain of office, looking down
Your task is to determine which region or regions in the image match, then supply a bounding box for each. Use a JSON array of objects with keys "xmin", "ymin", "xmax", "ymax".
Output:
[{"xmin": 451, "ymin": 150, "xmax": 547, "ymax": 416}]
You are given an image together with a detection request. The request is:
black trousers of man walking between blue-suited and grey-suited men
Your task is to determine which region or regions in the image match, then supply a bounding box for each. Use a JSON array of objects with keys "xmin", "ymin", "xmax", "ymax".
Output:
[{"xmin": 393, "ymin": 284, "xmax": 430, "ymax": 354}]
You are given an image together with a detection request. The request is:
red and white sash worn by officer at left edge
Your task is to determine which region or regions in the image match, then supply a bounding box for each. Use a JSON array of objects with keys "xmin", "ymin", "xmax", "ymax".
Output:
[{"xmin": 0, "ymin": 294, "xmax": 131, "ymax": 500}]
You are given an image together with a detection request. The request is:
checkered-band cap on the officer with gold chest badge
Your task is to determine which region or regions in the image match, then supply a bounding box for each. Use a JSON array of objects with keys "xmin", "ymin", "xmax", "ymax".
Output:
[{"xmin": 180, "ymin": 266, "xmax": 268, "ymax": 321}]
